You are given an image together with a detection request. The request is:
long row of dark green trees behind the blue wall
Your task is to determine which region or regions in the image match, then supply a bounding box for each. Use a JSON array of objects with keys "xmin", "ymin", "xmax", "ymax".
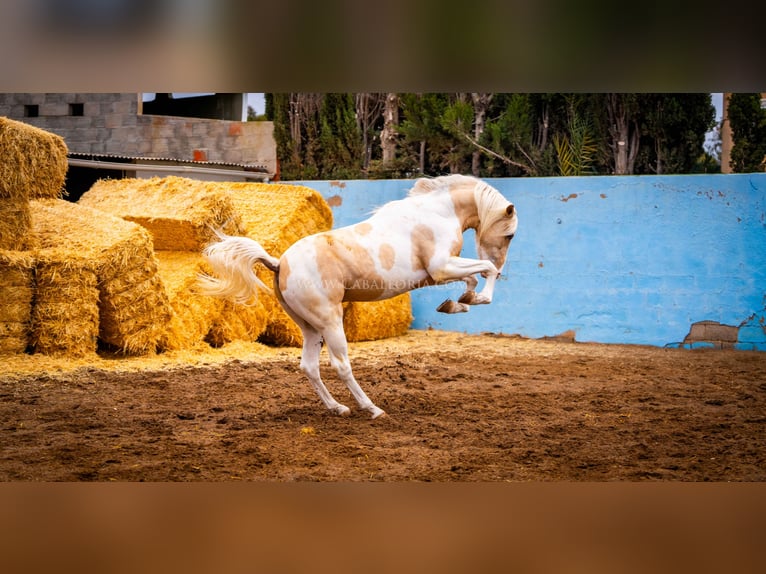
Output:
[{"xmin": 266, "ymin": 93, "xmax": 720, "ymax": 179}]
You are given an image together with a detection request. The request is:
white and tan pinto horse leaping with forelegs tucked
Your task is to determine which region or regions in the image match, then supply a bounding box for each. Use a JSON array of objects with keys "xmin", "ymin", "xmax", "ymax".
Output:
[{"xmin": 199, "ymin": 175, "xmax": 518, "ymax": 418}]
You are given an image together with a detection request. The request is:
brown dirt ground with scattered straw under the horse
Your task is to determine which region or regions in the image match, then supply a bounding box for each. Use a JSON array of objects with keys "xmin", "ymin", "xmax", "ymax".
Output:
[{"xmin": 0, "ymin": 331, "xmax": 766, "ymax": 482}]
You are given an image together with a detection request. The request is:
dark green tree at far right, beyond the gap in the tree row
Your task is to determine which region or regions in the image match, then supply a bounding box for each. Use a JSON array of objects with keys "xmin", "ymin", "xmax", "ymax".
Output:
[{"xmin": 728, "ymin": 94, "xmax": 766, "ymax": 173}]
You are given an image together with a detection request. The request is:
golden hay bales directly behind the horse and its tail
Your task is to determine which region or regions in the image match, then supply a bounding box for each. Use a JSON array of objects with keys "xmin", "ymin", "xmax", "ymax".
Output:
[{"xmin": 78, "ymin": 176, "xmax": 412, "ymax": 349}]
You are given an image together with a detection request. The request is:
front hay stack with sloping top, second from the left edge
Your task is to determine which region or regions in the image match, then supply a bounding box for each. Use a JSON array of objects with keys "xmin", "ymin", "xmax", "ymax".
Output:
[{"xmin": 31, "ymin": 200, "xmax": 170, "ymax": 355}]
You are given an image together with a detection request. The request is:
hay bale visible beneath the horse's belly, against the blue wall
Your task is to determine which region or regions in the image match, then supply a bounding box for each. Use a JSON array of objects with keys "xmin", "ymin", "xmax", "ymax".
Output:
[{"xmin": 343, "ymin": 293, "xmax": 412, "ymax": 342}]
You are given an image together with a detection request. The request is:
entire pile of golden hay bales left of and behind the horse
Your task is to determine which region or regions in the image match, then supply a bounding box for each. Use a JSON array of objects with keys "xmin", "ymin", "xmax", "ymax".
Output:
[{"xmin": 0, "ymin": 112, "xmax": 411, "ymax": 356}]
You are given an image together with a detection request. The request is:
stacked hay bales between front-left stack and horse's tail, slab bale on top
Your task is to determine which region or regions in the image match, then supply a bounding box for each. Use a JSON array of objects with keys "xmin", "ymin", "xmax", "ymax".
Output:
[{"xmin": 78, "ymin": 176, "xmax": 267, "ymax": 350}]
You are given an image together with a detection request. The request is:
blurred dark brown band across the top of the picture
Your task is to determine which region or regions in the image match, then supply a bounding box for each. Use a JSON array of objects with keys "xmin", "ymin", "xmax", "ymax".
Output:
[{"xmin": 0, "ymin": 0, "xmax": 766, "ymax": 92}]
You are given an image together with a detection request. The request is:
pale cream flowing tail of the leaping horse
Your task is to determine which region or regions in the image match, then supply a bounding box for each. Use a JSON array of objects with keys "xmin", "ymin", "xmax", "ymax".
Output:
[{"xmin": 197, "ymin": 230, "xmax": 279, "ymax": 305}]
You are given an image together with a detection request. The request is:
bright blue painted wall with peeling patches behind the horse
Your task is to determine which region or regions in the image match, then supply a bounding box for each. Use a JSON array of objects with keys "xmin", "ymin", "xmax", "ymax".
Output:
[{"xmin": 294, "ymin": 174, "xmax": 766, "ymax": 350}]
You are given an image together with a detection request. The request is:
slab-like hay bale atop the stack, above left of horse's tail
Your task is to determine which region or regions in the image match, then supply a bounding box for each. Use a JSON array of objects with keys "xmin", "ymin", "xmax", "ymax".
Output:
[{"xmin": 77, "ymin": 176, "xmax": 242, "ymax": 251}]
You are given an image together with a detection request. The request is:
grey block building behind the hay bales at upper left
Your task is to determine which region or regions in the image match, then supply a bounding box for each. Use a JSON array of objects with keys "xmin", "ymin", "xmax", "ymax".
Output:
[{"xmin": 0, "ymin": 92, "xmax": 277, "ymax": 201}]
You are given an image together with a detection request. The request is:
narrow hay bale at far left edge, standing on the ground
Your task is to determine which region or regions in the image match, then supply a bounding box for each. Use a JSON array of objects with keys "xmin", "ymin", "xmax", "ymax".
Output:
[{"xmin": 0, "ymin": 251, "xmax": 35, "ymax": 355}]
